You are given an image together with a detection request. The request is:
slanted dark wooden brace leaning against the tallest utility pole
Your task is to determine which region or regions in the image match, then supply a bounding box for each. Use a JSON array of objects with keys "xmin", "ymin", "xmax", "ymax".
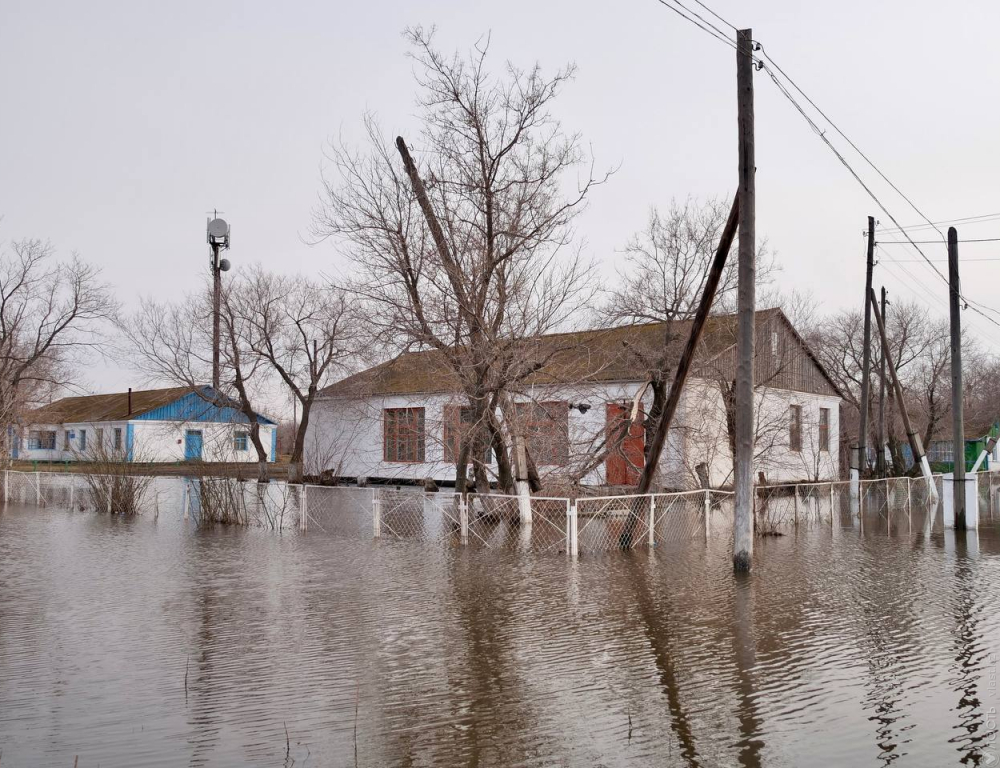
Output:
[{"xmin": 636, "ymin": 194, "xmax": 740, "ymax": 494}]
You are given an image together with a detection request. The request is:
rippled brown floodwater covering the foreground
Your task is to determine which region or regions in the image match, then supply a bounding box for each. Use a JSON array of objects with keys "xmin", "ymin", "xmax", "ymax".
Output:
[{"xmin": 0, "ymin": 496, "xmax": 1000, "ymax": 768}]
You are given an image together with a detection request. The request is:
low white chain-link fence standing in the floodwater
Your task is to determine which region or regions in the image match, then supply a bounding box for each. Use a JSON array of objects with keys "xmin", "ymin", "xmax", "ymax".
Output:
[{"xmin": 2, "ymin": 470, "xmax": 1000, "ymax": 553}]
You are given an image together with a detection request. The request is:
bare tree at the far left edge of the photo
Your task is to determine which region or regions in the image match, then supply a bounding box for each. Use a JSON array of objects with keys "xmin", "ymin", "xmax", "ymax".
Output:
[{"xmin": 0, "ymin": 240, "xmax": 116, "ymax": 456}]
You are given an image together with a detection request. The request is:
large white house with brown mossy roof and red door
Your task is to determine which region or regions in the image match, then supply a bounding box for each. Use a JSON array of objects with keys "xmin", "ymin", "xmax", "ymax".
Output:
[{"xmin": 305, "ymin": 309, "xmax": 842, "ymax": 488}]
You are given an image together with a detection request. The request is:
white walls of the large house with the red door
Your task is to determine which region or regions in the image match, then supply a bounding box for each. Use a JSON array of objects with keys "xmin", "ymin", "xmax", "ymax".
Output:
[{"xmin": 305, "ymin": 379, "xmax": 840, "ymax": 488}]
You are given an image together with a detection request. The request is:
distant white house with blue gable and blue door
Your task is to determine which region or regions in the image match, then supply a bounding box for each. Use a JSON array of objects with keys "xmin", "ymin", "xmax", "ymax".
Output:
[{"xmin": 10, "ymin": 386, "xmax": 277, "ymax": 462}]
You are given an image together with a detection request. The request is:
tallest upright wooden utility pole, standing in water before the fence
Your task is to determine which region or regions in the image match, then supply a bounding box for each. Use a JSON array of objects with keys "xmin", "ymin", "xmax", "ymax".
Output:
[{"xmin": 733, "ymin": 29, "xmax": 757, "ymax": 571}]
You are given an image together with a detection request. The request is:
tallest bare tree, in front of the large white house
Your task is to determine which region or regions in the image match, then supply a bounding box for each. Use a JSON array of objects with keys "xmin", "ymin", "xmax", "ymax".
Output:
[{"xmin": 313, "ymin": 28, "xmax": 607, "ymax": 490}]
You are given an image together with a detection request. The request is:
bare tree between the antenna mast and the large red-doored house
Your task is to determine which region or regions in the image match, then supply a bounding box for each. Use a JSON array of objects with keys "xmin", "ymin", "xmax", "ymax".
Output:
[{"xmin": 232, "ymin": 267, "xmax": 358, "ymax": 480}]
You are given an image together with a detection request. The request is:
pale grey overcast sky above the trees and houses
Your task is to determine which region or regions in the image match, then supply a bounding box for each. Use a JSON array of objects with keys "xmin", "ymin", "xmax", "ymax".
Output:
[{"xmin": 0, "ymin": 0, "xmax": 1000, "ymax": 408}]
